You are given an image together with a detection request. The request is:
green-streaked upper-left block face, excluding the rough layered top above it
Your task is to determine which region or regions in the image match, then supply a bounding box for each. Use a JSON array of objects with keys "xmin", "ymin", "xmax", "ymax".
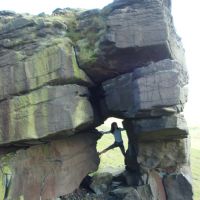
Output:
[{"xmin": 0, "ymin": 39, "xmax": 92, "ymax": 100}]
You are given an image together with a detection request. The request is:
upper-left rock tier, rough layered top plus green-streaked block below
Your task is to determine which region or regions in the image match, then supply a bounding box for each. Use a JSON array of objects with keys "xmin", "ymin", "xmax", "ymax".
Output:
[{"xmin": 0, "ymin": 13, "xmax": 92, "ymax": 100}]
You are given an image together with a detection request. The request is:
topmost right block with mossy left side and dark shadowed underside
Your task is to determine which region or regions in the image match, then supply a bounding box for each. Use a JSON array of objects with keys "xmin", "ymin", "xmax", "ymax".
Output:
[{"xmin": 75, "ymin": 0, "xmax": 184, "ymax": 82}]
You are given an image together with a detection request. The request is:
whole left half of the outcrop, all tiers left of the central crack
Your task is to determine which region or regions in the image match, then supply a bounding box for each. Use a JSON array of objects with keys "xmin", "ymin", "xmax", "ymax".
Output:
[{"xmin": 0, "ymin": 9, "xmax": 99, "ymax": 200}]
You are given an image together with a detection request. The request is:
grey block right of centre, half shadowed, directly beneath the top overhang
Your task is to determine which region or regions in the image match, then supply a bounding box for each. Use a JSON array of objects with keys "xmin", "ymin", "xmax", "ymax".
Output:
[{"xmin": 103, "ymin": 59, "xmax": 188, "ymax": 118}]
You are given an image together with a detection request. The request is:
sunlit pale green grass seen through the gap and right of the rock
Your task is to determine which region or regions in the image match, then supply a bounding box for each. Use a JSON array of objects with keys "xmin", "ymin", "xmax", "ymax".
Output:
[{"xmin": 97, "ymin": 121, "xmax": 200, "ymax": 200}]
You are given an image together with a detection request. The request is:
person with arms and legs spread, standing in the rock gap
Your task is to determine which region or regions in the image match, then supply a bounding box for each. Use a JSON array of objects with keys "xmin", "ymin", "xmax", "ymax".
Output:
[{"xmin": 99, "ymin": 122, "xmax": 125, "ymax": 156}]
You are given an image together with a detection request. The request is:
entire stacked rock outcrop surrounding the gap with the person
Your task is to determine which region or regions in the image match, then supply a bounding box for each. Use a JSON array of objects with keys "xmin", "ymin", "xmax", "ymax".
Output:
[{"xmin": 0, "ymin": 0, "xmax": 192, "ymax": 200}]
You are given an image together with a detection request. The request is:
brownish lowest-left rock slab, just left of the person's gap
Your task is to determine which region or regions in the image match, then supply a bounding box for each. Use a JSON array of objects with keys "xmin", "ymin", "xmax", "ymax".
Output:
[{"xmin": 0, "ymin": 134, "xmax": 99, "ymax": 200}]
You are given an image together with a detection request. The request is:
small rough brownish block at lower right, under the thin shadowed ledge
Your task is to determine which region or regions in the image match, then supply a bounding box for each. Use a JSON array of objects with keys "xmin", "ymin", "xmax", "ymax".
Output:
[{"xmin": 137, "ymin": 139, "xmax": 189, "ymax": 170}]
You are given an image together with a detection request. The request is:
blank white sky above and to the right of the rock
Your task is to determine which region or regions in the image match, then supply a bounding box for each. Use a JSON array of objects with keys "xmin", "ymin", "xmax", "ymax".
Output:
[{"xmin": 0, "ymin": 0, "xmax": 200, "ymax": 126}]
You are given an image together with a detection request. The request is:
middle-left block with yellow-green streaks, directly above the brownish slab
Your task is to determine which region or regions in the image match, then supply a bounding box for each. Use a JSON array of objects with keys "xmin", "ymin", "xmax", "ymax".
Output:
[{"xmin": 0, "ymin": 85, "xmax": 94, "ymax": 144}]
